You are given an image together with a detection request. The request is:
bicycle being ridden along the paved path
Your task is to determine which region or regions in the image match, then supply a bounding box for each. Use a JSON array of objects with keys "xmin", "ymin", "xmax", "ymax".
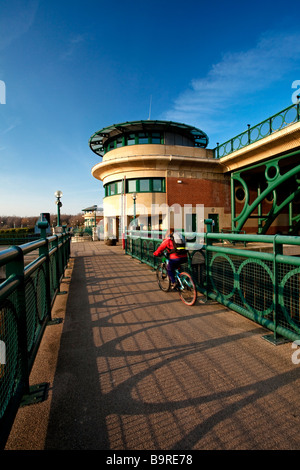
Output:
[{"xmin": 156, "ymin": 254, "xmax": 197, "ymax": 306}]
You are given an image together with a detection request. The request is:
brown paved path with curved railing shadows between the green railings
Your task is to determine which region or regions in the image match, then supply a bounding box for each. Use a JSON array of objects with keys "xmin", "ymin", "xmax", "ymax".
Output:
[{"xmin": 6, "ymin": 242, "xmax": 300, "ymax": 450}]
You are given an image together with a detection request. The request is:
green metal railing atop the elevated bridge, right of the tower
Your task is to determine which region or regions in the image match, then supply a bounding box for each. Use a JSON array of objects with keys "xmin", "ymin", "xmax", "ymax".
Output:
[{"xmin": 214, "ymin": 102, "xmax": 300, "ymax": 158}]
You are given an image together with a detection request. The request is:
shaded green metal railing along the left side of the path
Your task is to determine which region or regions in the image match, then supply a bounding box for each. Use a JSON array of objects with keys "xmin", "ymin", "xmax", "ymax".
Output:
[{"xmin": 0, "ymin": 222, "xmax": 70, "ymax": 448}]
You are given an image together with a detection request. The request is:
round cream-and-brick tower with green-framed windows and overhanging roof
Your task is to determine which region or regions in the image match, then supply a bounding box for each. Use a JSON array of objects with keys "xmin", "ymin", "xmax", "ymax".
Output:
[{"xmin": 89, "ymin": 120, "xmax": 230, "ymax": 238}]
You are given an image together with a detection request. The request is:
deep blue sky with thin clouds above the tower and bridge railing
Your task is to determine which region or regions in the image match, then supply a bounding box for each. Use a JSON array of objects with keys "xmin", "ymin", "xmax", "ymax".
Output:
[{"xmin": 0, "ymin": 0, "xmax": 300, "ymax": 216}]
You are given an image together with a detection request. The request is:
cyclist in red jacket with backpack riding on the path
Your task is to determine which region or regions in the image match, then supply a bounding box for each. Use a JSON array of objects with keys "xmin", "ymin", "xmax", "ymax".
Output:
[{"xmin": 153, "ymin": 228, "xmax": 187, "ymax": 289}]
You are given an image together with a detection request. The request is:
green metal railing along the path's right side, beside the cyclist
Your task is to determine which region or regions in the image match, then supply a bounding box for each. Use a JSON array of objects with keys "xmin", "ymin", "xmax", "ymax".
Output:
[{"xmin": 125, "ymin": 232, "xmax": 300, "ymax": 342}]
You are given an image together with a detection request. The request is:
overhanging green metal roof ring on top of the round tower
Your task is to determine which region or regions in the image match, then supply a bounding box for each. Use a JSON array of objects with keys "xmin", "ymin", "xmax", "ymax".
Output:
[{"xmin": 89, "ymin": 120, "xmax": 208, "ymax": 156}]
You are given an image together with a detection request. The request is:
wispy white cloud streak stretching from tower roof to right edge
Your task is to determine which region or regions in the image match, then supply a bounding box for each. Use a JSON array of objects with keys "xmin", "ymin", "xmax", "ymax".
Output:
[{"xmin": 164, "ymin": 32, "xmax": 300, "ymax": 134}]
